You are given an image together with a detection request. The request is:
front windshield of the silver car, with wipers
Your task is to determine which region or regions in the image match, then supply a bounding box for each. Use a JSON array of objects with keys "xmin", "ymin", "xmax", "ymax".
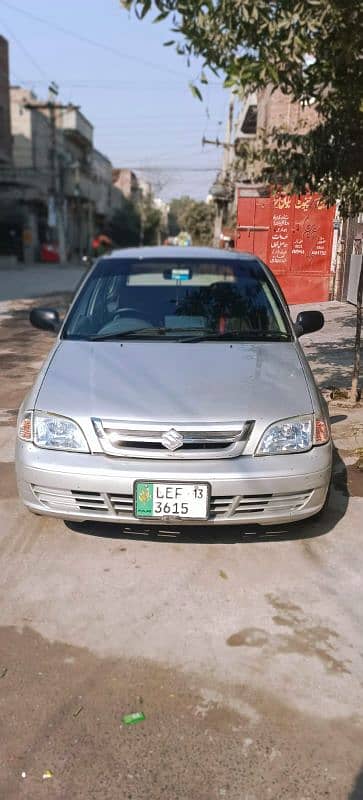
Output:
[{"xmin": 62, "ymin": 257, "xmax": 291, "ymax": 342}]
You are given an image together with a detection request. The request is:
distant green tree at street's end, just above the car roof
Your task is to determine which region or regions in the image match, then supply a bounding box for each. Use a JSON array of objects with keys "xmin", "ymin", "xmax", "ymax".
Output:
[{"xmin": 169, "ymin": 196, "xmax": 215, "ymax": 245}]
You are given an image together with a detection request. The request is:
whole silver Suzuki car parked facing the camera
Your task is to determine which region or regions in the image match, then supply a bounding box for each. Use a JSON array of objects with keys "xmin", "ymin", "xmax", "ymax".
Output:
[{"xmin": 16, "ymin": 247, "xmax": 332, "ymax": 526}]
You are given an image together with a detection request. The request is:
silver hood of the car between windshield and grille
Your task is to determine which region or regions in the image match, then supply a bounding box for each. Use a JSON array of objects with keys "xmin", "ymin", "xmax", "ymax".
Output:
[{"xmin": 36, "ymin": 340, "xmax": 312, "ymax": 423}]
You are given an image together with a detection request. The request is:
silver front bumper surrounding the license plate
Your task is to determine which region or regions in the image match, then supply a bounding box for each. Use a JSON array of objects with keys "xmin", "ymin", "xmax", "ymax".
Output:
[{"xmin": 16, "ymin": 440, "xmax": 332, "ymax": 526}]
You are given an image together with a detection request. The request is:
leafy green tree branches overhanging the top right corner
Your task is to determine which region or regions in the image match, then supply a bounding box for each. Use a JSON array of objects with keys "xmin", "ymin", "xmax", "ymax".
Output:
[{"xmin": 121, "ymin": 0, "xmax": 363, "ymax": 214}]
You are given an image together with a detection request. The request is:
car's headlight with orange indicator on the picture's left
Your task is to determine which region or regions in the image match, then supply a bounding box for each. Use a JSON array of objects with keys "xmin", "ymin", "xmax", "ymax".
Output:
[{"xmin": 18, "ymin": 411, "xmax": 89, "ymax": 453}]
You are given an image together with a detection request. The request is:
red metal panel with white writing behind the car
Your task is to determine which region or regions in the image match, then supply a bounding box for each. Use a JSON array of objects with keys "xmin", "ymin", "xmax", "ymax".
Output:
[{"xmin": 236, "ymin": 194, "xmax": 335, "ymax": 303}]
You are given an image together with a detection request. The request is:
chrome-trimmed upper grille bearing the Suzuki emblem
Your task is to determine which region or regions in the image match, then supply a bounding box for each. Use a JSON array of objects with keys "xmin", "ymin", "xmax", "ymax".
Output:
[{"xmin": 92, "ymin": 419, "xmax": 253, "ymax": 459}]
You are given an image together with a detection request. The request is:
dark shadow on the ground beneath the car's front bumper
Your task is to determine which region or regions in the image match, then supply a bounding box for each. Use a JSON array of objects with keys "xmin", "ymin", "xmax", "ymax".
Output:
[{"xmin": 65, "ymin": 447, "xmax": 349, "ymax": 544}]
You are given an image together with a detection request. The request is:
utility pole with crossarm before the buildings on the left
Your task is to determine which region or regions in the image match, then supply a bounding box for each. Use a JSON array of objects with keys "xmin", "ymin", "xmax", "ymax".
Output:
[{"xmin": 24, "ymin": 82, "xmax": 79, "ymax": 263}]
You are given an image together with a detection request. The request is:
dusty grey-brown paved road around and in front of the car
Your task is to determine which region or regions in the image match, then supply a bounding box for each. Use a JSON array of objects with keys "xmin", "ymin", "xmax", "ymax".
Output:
[{"xmin": 0, "ymin": 297, "xmax": 363, "ymax": 800}]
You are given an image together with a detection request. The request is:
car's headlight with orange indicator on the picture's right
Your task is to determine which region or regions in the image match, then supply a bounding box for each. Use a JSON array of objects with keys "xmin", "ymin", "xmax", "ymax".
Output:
[{"xmin": 256, "ymin": 414, "xmax": 330, "ymax": 456}]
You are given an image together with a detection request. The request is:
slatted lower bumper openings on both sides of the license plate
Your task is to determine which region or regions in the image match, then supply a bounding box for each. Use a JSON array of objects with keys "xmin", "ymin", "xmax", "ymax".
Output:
[{"xmin": 32, "ymin": 486, "xmax": 312, "ymax": 524}]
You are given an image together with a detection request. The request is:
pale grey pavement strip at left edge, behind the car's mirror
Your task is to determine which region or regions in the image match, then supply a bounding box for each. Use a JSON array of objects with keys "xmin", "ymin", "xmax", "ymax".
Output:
[{"xmin": 0, "ymin": 264, "xmax": 86, "ymax": 302}]
